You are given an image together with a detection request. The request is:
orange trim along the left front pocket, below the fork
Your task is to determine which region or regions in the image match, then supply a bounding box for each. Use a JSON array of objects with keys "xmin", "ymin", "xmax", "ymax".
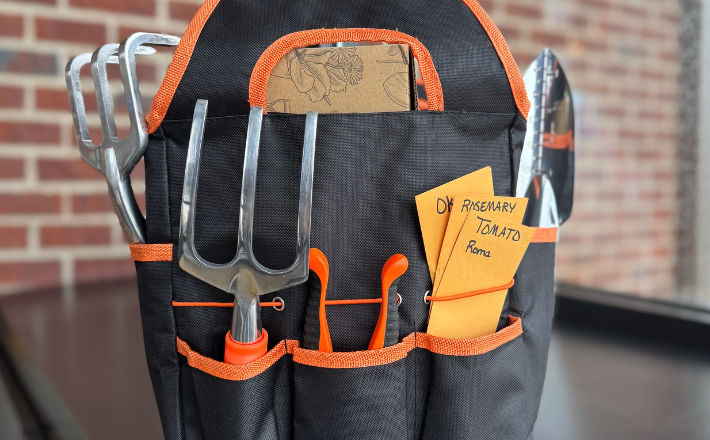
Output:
[{"xmin": 176, "ymin": 338, "xmax": 298, "ymax": 380}]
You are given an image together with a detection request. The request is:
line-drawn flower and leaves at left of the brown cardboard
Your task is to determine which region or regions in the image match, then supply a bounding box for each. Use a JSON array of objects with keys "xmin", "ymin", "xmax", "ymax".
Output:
[{"xmin": 272, "ymin": 47, "xmax": 364, "ymax": 105}]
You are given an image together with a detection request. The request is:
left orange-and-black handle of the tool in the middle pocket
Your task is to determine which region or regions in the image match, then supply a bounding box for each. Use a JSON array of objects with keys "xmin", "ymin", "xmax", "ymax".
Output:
[{"xmin": 303, "ymin": 248, "xmax": 333, "ymax": 353}]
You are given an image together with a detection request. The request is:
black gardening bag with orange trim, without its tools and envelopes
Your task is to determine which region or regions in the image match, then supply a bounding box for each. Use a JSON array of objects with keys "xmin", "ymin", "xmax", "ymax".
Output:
[{"xmin": 134, "ymin": 0, "xmax": 555, "ymax": 440}]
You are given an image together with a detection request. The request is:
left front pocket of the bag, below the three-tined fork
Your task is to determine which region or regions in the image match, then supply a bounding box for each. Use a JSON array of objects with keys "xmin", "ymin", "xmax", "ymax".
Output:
[{"xmin": 178, "ymin": 339, "xmax": 297, "ymax": 440}]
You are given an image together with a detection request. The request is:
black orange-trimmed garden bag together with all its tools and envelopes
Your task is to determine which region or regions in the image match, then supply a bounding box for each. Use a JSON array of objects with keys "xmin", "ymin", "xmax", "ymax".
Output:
[{"xmin": 66, "ymin": 0, "xmax": 574, "ymax": 440}]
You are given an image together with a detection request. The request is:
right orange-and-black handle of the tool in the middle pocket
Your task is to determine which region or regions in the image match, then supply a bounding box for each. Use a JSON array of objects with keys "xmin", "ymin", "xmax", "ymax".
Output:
[{"xmin": 369, "ymin": 254, "xmax": 409, "ymax": 350}]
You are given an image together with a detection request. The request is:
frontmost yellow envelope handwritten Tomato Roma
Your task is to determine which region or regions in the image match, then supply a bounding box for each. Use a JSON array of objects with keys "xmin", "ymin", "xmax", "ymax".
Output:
[{"xmin": 427, "ymin": 212, "xmax": 535, "ymax": 339}]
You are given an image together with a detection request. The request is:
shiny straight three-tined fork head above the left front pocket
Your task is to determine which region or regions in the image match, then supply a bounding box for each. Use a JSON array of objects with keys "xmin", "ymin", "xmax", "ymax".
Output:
[{"xmin": 178, "ymin": 100, "xmax": 318, "ymax": 343}]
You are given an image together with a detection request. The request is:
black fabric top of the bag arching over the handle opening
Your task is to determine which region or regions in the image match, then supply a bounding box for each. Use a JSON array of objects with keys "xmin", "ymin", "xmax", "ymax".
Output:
[{"xmin": 167, "ymin": 0, "xmax": 517, "ymax": 120}]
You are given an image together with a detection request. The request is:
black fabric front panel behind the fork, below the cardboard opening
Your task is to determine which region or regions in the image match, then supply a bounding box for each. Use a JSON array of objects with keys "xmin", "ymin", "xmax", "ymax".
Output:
[{"xmin": 163, "ymin": 112, "xmax": 520, "ymax": 359}]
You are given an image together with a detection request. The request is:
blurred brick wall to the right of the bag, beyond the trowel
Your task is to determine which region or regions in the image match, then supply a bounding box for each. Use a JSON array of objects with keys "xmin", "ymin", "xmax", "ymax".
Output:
[{"xmin": 485, "ymin": 0, "xmax": 680, "ymax": 299}]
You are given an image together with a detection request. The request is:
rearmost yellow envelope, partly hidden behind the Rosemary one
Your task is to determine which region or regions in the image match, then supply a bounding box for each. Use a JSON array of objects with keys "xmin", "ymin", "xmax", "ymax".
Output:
[{"xmin": 415, "ymin": 167, "xmax": 493, "ymax": 282}]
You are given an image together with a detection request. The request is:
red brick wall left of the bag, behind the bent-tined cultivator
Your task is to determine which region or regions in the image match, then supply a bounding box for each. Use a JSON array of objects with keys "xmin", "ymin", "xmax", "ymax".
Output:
[{"xmin": 0, "ymin": 0, "xmax": 202, "ymax": 294}]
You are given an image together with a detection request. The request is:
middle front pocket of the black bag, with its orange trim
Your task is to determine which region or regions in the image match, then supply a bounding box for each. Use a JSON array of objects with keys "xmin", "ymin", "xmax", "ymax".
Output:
[{"xmin": 293, "ymin": 334, "xmax": 414, "ymax": 440}]
